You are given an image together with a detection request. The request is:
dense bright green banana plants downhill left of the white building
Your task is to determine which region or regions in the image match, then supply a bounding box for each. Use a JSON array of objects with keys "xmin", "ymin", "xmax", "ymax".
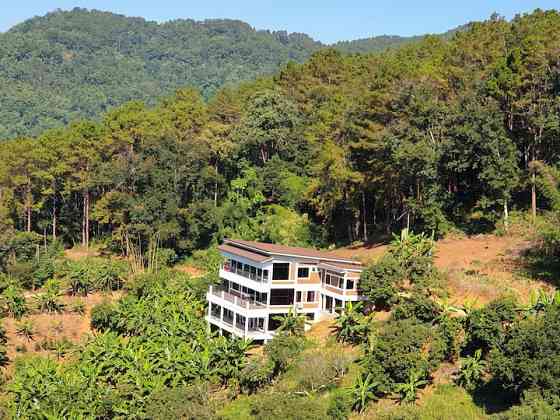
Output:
[{"xmin": 8, "ymin": 273, "xmax": 250, "ymax": 418}]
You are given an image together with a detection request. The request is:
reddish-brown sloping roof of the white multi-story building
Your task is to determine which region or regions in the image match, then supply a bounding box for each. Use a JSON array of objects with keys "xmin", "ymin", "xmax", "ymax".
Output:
[{"xmin": 222, "ymin": 239, "xmax": 361, "ymax": 269}]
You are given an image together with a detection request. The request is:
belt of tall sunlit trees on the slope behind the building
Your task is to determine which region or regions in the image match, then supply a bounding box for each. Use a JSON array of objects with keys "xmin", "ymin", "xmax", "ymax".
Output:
[{"xmin": 0, "ymin": 11, "xmax": 560, "ymax": 254}]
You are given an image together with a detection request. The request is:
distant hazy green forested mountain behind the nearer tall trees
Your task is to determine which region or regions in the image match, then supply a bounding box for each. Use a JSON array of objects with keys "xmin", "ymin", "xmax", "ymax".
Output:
[{"xmin": 0, "ymin": 9, "xmax": 450, "ymax": 139}]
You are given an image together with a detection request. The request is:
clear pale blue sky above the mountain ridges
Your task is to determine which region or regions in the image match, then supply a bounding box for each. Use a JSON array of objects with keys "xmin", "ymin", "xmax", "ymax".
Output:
[{"xmin": 0, "ymin": 0, "xmax": 560, "ymax": 43}]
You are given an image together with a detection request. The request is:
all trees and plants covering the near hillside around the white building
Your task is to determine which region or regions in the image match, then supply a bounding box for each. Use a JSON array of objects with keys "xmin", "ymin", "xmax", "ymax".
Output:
[{"xmin": 0, "ymin": 10, "xmax": 560, "ymax": 420}]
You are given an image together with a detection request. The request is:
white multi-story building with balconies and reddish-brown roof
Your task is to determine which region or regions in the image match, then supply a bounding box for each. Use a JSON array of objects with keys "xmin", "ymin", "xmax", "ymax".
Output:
[{"xmin": 207, "ymin": 239, "xmax": 362, "ymax": 341}]
